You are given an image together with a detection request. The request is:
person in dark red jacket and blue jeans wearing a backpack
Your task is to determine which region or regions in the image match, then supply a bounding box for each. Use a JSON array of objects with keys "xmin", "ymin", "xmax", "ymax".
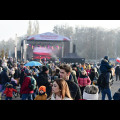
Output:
[{"xmin": 20, "ymin": 69, "xmax": 34, "ymax": 100}]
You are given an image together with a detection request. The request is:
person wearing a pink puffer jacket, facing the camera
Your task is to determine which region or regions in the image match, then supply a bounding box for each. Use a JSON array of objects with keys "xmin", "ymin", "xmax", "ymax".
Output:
[{"xmin": 78, "ymin": 70, "xmax": 91, "ymax": 96}]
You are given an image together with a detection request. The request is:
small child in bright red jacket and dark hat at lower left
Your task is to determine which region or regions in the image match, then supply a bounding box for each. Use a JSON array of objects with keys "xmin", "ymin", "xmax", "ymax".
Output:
[{"xmin": 4, "ymin": 84, "xmax": 17, "ymax": 100}]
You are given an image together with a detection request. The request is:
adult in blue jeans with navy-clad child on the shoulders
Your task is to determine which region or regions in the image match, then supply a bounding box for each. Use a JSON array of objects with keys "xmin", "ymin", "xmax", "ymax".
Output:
[{"xmin": 99, "ymin": 56, "xmax": 112, "ymax": 100}]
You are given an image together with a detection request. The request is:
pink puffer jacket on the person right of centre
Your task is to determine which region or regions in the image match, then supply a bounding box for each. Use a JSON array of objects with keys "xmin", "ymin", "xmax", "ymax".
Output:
[{"xmin": 78, "ymin": 75, "xmax": 91, "ymax": 87}]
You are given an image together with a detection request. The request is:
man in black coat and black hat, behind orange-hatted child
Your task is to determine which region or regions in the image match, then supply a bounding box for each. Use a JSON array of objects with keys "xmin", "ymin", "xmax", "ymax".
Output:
[{"xmin": 37, "ymin": 66, "xmax": 52, "ymax": 97}]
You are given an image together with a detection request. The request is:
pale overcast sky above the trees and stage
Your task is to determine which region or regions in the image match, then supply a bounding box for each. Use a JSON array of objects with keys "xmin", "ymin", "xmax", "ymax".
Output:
[{"xmin": 0, "ymin": 20, "xmax": 120, "ymax": 40}]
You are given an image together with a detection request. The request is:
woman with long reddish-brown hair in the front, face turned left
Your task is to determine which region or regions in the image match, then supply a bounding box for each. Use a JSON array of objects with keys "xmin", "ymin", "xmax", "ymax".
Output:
[{"xmin": 48, "ymin": 78, "xmax": 73, "ymax": 100}]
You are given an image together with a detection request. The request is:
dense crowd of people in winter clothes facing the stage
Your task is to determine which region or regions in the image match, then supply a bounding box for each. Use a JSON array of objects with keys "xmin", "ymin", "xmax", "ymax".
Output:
[{"xmin": 0, "ymin": 56, "xmax": 120, "ymax": 100}]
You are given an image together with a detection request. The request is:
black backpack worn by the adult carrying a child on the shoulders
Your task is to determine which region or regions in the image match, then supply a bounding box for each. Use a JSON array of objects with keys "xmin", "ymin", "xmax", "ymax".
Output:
[{"xmin": 97, "ymin": 74, "xmax": 106, "ymax": 88}]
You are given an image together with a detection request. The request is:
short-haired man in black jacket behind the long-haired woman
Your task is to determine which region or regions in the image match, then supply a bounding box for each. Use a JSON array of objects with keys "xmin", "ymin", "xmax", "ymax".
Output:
[{"xmin": 60, "ymin": 64, "xmax": 82, "ymax": 100}]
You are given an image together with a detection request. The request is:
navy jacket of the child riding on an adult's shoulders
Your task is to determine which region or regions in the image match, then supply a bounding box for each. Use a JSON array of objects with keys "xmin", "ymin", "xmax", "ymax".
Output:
[{"xmin": 100, "ymin": 59, "xmax": 112, "ymax": 73}]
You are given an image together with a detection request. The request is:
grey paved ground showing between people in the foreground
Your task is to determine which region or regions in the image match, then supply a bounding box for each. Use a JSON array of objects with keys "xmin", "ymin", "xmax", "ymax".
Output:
[{"xmin": 1, "ymin": 77, "xmax": 120, "ymax": 100}]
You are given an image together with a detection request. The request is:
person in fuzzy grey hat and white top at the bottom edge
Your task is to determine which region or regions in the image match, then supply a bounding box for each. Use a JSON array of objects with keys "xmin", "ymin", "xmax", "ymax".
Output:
[{"xmin": 83, "ymin": 85, "xmax": 99, "ymax": 100}]
